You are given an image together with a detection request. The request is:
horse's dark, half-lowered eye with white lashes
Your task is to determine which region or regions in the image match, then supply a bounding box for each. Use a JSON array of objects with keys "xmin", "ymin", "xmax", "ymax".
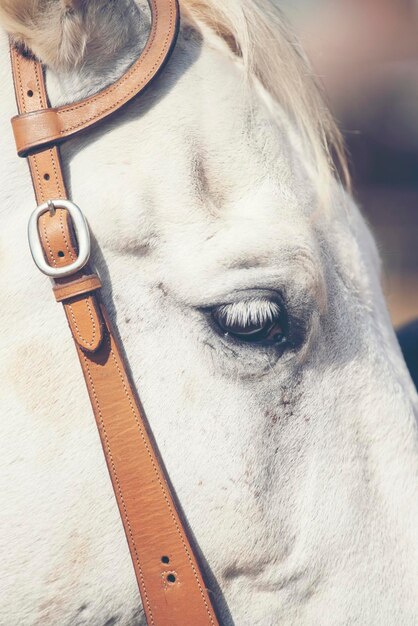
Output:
[{"xmin": 212, "ymin": 301, "xmax": 287, "ymax": 345}]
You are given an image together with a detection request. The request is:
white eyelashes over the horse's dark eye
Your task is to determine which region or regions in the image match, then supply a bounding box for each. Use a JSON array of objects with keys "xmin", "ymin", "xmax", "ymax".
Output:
[{"xmin": 218, "ymin": 298, "xmax": 280, "ymax": 327}]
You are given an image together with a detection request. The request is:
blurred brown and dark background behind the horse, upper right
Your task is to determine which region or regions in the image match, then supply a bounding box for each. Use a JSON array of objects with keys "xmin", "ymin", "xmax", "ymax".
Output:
[{"xmin": 281, "ymin": 0, "xmax": 418, "ymax": 326}]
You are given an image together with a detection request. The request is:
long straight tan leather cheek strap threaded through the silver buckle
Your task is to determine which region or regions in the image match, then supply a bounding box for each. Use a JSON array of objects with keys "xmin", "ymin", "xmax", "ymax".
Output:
[{"xmin": 11, "ymin": 0, "xmax": 218, "ymax": 626}]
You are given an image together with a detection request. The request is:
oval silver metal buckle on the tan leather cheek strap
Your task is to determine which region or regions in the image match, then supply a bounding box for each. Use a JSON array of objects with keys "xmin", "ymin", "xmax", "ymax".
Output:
[{"xmin": 28, "ymin": 200, "xmax": 91, "ymax": 278}]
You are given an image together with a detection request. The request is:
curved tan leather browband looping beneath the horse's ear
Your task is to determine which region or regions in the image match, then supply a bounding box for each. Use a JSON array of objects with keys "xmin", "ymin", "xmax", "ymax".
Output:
[{"xmin": 12, "ymin": 0, "xmax": 179, "ymax": 156}]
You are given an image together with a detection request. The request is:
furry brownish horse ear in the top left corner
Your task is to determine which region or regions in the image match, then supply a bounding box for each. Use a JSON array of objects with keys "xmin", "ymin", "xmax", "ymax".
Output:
[{"xmin": 0, "ymin": 0, "xmax": 87, "ymax": 69}]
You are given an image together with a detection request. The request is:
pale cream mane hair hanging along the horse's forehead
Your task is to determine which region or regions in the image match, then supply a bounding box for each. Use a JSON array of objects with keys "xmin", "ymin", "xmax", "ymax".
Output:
[{"xmin": 181, "ymin": 0, "xmax": 351, "ymax": 188}]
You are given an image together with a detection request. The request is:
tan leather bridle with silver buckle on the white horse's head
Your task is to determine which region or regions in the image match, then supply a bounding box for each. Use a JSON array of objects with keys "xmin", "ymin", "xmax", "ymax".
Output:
[{"xmin": 11, "ymin": 0, "xmax": 218, "ymax": 626}]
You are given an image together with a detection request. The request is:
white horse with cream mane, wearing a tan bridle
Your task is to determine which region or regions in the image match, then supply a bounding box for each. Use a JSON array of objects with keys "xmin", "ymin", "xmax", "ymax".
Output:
[{"xmin": 0, "ymin": 0, "xmax": 418, "ymax": 626}]
